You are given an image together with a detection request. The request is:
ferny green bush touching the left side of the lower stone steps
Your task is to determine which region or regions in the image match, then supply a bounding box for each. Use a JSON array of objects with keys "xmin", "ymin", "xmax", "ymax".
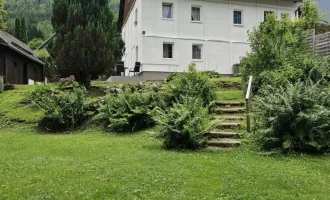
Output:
[{"xmin": 154, "ymin": 97, "xmax": 214, "ymax": 149}]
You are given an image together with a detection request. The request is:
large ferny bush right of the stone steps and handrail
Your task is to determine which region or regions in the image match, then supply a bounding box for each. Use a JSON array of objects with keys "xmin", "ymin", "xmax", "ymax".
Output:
[{"xmin": 255, "ymin": 80, "xmax": 330, "ymax": 152}]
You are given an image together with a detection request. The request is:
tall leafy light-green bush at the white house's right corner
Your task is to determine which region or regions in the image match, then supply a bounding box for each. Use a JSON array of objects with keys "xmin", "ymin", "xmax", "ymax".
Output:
[{"xmin": 241, "ymin": 0, "xmax": 321, "ymax": 88}]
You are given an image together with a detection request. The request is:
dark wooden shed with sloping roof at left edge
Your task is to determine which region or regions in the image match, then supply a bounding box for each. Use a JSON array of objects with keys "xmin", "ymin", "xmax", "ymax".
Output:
[{"xmin": 0, "ymin": 30, "xmax": 44, "ymax": 84}]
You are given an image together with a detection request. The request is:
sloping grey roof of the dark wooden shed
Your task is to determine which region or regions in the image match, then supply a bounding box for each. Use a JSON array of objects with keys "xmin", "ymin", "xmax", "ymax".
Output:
[{"xmin": 0, "ymin": 30, "xmax": 44, "ymax": 65}]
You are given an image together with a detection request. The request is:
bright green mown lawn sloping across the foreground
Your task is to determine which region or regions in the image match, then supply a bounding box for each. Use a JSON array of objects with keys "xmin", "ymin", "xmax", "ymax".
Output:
[{"xmin": 0, "ymin": 80, "xmax": 330, "ymax": 199}]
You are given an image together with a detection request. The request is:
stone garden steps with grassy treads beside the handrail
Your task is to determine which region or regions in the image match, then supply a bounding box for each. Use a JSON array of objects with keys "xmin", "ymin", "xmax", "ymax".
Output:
[{"xmin": 207, "ymin": 101, "xmax": 245, "ymax": 148}]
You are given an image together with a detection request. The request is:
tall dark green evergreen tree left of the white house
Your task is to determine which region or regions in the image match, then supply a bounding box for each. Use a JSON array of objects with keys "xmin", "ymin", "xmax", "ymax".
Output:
[{"xmin": 51, "ymin": 0, "xmax": 124, "ymax": 87}]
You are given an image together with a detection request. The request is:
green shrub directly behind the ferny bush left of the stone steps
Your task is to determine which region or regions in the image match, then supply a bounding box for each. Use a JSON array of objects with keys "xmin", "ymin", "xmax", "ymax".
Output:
[{"xmin": 164, "ymin": 64, "xmax": 215, "ymax": 106}]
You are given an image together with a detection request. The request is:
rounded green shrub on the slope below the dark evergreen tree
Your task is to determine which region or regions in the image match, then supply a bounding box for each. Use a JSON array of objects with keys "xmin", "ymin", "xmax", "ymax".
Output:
[{"xmin": 35, "ymin": 88, "xmax": 88, "ymax": 131}]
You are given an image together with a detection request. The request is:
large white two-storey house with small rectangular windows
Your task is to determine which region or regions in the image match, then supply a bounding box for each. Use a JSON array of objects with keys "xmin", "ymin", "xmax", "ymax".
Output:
[{"xmin": 118, "ymin": 0, "xmax": 298, "ymax": 80}]
